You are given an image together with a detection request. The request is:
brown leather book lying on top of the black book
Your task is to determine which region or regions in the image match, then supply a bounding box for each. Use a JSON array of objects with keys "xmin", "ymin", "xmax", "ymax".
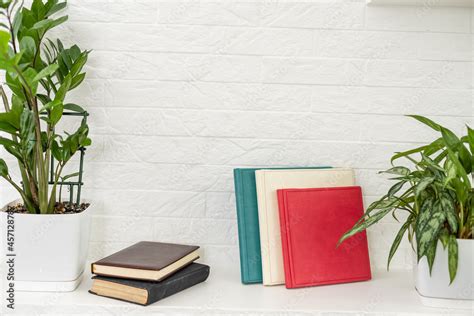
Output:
[{"xmin": 91, "ymin": 241, "xmax": 199, "ymax": 281}]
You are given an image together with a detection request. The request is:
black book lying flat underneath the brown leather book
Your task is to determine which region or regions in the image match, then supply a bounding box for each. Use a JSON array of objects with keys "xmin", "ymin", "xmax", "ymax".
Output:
[{"xmin": 89, "ymin": 263, "xmax": 210, "ymax": 306}]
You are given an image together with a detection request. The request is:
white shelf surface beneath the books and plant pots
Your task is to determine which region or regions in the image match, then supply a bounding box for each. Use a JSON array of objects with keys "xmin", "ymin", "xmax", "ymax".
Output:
[{"xmin": 8, "ymin": 267, "xmax": 474, "ymax": 316}]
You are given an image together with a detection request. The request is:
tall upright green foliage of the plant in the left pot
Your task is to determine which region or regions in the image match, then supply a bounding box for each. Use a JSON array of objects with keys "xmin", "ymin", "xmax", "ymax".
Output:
[{"xmin": 0, "ymin": 0, "xmax": 91, "ymax": 214}]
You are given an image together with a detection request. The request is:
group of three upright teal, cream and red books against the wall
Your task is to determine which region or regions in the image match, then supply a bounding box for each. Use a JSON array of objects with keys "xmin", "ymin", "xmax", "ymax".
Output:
[{"xmin": 234, "ymin": 167, "xmax": 371, "ymax": 288}]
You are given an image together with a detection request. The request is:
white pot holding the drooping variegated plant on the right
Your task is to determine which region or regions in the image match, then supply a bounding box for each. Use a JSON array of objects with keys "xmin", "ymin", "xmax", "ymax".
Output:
[{"xmin": 414, "ymin": 239, "xmax": 474, "ymax": 304}]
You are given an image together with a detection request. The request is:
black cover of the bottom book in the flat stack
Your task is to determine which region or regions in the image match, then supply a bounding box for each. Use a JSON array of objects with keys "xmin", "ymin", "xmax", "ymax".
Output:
[{"xmin": 89, "ymin": 263, "xmax": 210, "ymax": 306}]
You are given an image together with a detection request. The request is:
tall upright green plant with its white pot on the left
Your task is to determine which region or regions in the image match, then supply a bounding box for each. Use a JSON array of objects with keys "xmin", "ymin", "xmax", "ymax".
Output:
[{"xmin": 0, "ymin": 0, "xmax": 91, "ymax": 291}]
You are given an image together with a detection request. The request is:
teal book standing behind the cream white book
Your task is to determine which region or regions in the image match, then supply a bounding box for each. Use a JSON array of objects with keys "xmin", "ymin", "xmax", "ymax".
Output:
[{"xmin": 234, "ymin": 167, "xmax": 331, "ymax": 284}]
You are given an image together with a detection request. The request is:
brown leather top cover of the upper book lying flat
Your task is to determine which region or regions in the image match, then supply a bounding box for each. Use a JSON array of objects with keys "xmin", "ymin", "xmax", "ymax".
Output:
[{"xmin": 92, "ymin": 241, "xmax": 199, "ymax": 271}]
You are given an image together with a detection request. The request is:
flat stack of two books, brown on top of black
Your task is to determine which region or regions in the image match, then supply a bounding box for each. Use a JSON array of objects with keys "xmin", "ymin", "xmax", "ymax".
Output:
[{"xmin": 89, "ymin": 241, "xmax": 210, "ymax": 305}]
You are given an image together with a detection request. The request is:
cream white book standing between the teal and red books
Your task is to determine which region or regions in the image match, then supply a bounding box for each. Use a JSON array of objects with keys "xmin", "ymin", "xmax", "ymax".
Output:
[{"xmin": 255, "ymin": 168, "xmax": 355, "ymax": 285}]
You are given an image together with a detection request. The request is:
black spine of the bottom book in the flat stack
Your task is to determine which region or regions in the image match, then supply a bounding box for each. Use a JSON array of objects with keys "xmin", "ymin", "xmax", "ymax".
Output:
[{"xmin": 145, "ymin": 266, "xmax": 210, "ymax": 305}]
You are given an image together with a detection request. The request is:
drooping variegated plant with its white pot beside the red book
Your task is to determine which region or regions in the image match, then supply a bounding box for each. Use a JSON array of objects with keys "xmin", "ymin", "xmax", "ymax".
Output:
[{"xmin": 340, "ymin": 115, "xmax": 474, "ymax": 299}]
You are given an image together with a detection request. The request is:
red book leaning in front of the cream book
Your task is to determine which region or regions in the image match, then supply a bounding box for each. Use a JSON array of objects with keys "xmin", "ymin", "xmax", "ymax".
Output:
[{"xmin": 278, "ymin": 186, "xmax": 371, "ymax": 288}]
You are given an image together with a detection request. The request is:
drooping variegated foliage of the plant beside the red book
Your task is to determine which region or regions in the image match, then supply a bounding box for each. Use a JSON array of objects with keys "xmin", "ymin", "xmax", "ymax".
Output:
[{"xmin": 340, "ymin": 115, "xmax": 474, "ymax": 283}]
